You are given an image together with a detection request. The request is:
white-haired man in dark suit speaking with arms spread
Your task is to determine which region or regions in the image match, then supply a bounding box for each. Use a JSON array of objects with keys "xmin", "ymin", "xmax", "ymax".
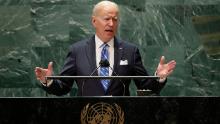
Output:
[{"xmin": 35, "ymin": 1, "xmax": 176, "ymax": 96}]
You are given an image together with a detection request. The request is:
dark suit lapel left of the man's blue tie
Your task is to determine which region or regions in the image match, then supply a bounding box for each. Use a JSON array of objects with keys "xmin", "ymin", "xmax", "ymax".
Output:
[{"xmin": 86, "ymin": 36, "xmax": 98, "ymax": 76}]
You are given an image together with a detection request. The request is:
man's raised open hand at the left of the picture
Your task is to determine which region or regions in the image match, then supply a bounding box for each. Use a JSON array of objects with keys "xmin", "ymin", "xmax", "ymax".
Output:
[{"xmin": 35, "ymin": 62, "xmax": 53, "ymax": 84}]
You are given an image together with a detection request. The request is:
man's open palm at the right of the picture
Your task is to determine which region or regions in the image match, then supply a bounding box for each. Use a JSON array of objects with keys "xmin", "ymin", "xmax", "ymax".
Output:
[{"xmin": 157, "ymin": 56, "xmax": 176, "ymax": 79}]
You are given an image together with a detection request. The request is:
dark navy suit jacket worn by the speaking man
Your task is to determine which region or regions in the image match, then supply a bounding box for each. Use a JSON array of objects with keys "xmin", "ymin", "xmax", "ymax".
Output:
[{"xmin": 43, "ymin": 36, "xmax": 165, "ymax": 96}]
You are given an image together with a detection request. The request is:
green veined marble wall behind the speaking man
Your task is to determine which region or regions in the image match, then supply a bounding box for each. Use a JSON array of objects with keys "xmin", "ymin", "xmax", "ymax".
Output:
[{"xmin": 0, "ymin": 0, "xmax": 220, "ymax": 97}]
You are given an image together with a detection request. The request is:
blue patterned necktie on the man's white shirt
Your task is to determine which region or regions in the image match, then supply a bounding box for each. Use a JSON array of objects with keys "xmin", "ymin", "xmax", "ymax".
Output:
[{"xmin": 99, "ymin": 44, "xmax": 110, "ymax": 92}]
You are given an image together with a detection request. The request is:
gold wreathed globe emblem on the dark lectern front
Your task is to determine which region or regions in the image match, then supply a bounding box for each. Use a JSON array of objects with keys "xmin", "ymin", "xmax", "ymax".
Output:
[{"xmin": 81, "ymin": 102, "xmax": 124, "ymax": 124}]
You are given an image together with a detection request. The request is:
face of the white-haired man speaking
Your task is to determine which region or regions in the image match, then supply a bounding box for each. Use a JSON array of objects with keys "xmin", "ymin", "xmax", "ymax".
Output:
[{"xmin": 92, "ymin": 6, "xmax": 119, "ymax": 42}]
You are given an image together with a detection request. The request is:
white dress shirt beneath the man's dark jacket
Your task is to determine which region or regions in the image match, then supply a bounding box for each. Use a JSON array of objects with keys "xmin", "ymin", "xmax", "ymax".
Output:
[{"xmin": 95, "ymin": 35, "xmax": 114, "ymax": 76}]
